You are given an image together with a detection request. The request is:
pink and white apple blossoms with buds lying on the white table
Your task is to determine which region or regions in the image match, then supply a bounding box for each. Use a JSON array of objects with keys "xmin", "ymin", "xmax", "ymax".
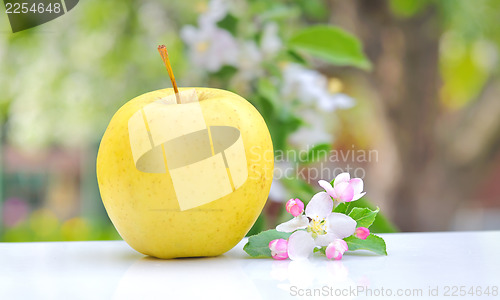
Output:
[{"xmin": 269, "ymin": 173, "xmax": 370, "ymax": 260}]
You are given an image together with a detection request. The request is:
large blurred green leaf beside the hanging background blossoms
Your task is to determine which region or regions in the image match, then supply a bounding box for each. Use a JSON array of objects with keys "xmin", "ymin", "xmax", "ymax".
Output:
[{"xmin": 288, "ymin": 25, "xmax": 371, "ymax": 70}]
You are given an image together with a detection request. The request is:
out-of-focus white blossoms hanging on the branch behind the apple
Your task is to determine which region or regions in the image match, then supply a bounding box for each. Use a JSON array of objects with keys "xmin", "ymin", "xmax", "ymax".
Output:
[{"xmin": 180, "ymin": 0, "xmax": 354, "ymax": 147}]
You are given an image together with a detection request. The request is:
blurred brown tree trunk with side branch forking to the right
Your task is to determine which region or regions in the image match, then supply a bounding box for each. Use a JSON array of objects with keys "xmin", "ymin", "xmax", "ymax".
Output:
[{"xmin": 330, "ymin": 0, "xmax": 500, "ymax": 231}]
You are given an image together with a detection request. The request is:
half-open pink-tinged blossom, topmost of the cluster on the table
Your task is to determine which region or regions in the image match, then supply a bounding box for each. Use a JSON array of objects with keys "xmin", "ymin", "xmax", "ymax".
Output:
[{"xmin": 318, "ymin": 173, "xmax": 366, "ymax": 202}]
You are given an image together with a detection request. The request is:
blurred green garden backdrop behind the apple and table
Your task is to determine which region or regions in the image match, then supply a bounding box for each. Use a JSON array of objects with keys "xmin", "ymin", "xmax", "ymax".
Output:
[{"xmin": 0, "ymin": 0, "xmax": 500, "ymax": 241}]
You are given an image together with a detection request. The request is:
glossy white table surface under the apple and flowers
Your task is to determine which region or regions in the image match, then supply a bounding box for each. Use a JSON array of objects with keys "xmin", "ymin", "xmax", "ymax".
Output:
[{"xmin": 0, "ymin": 231, "xmax": 500, "ymax": 299}]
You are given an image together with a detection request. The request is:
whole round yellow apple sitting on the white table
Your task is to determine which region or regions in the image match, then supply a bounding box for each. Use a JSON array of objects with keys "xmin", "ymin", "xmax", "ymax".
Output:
[{"xmin": 97, "ymin": 88, "xmax": 274, "ymax": 258}]
